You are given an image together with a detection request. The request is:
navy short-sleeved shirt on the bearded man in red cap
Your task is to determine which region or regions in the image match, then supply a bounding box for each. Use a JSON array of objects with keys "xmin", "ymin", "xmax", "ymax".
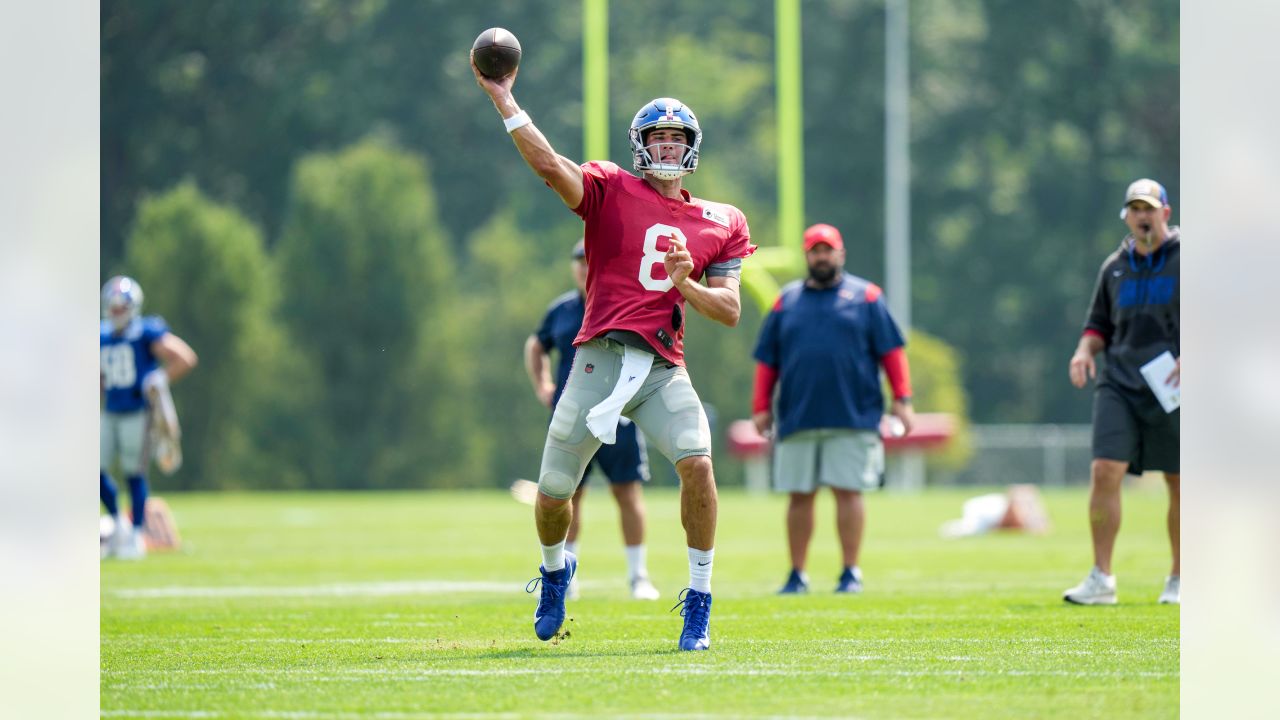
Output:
[{"xmin": 755, "ymin": 273, "xmax": 906, "ymax": 439}]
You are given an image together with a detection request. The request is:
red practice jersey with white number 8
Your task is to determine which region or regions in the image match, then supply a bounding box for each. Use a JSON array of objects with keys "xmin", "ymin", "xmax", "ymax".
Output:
[{"xmin": 573, "ymin": 161, "xmax": 755, "ymax": 365}]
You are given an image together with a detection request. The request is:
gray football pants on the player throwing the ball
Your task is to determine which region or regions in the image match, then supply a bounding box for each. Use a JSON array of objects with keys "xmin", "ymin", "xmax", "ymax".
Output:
[{"xmin": 538, "ymin": 338, "xmax": 712, "ymax": 498}]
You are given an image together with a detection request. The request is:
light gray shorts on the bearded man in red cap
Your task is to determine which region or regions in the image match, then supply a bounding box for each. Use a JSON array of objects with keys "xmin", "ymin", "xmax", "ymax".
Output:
[{"xmin": 773, "ymin": 428, "xmax": 884, "ymax": 493}]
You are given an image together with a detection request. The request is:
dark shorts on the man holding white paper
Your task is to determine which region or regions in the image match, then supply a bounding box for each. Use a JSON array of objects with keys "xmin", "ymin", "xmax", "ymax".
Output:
[{"xmin": 1093, "ymin": 384, "xmax": 1181, "ymax": 475}]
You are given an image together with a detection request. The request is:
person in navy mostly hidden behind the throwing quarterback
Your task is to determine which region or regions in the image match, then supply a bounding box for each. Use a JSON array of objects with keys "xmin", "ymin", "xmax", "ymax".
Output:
[{"xmin": 525, "ymin": 241, "xmax": 659, "ymax": 600}]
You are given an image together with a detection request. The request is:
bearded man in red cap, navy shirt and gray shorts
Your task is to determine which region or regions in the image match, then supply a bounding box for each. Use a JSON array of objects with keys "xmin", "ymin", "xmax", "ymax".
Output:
[{"xmin": 751, "ymin": 224, "xmax": 915, "ymax": 593}]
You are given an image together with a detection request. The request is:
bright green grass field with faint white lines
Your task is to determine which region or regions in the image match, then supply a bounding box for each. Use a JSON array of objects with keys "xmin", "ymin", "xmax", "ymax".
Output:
[{"xmin": 101, "ymin": 483, "xmax": 1179, "ymax": 719}]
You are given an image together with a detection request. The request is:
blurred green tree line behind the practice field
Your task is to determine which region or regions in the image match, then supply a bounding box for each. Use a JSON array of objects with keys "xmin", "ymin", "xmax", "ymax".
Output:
[{"xmin": 101, "ymin": 0, "xmax": 1179, "ymax": 488}]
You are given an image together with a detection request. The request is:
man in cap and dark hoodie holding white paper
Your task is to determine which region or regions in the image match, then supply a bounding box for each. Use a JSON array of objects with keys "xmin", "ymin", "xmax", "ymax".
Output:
[{"xmin": 1062, "ymin": 178, "xmax": 1181, "ymax": 605}]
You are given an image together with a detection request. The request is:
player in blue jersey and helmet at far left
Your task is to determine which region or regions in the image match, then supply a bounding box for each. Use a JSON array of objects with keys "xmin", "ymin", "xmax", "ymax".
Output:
[{"xmin": 99, "ymin": 275, "xmax": 197, "ymax": 559}]
